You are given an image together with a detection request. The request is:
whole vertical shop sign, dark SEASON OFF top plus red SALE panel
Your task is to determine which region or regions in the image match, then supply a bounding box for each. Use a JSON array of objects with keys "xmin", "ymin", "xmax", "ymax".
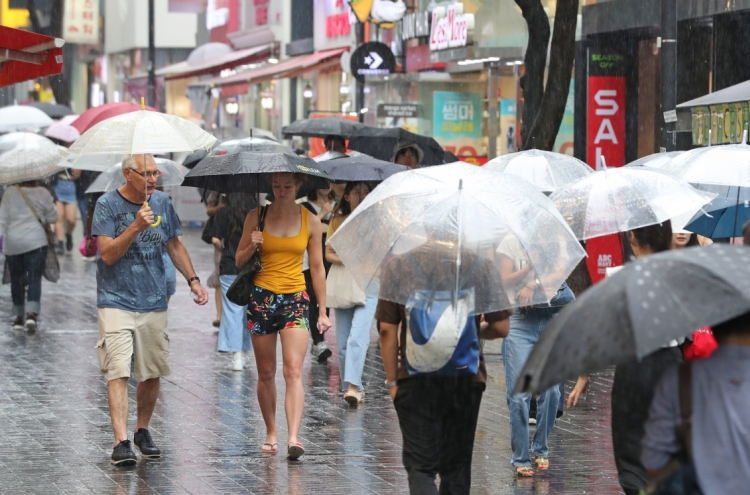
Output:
[{"xmin": 586, "ymin": 50, "xmax": 626, "ymax": 170}]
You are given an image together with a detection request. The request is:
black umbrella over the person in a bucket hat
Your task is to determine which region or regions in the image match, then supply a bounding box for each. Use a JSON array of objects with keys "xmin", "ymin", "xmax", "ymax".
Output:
[{"xmin": 349, "ymin": 127, "xmax": 445, "ymax": 166}]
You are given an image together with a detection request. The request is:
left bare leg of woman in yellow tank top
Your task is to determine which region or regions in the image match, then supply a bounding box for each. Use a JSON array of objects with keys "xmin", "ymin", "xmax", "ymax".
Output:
[{"xmin": 252, "ymin": 333, "xmax": 279, "ymax": 452}]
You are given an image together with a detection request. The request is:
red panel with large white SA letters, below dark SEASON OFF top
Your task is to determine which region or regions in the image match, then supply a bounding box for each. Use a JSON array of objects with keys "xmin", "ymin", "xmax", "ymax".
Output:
[{"xmin": 586, "ymin": 76, "xmax": 625, "ymax": 170}]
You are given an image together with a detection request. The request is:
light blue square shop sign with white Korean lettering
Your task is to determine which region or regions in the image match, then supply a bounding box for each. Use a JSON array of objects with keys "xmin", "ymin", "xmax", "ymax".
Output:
[{"xmin": 432, "ymin": 91, "xmax": 482, "ymax": 140}]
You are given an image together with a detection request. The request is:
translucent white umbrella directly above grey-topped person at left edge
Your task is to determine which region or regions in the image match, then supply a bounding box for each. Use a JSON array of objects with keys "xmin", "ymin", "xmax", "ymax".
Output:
[{"xmin": 0, "ymin": 146, "xmax": 65, "ymax": 185}]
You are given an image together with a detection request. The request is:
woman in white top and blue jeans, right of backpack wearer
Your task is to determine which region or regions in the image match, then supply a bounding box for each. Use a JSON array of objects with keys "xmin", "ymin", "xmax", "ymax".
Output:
[{"xmin": 497, "ymin": 235, "xmax": 575, "ymax": 477}]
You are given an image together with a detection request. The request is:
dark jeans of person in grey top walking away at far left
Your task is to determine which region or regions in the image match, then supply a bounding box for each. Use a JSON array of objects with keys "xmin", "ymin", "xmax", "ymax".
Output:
[{"xmin": 6, "ymin": 246, "xmax": 47, "ymax": 316}]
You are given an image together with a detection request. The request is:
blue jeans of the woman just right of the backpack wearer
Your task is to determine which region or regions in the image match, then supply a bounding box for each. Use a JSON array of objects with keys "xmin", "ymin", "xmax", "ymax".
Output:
[{"xmin": 502, "ymin": 311, "xmax": 560, "ymax": 466}]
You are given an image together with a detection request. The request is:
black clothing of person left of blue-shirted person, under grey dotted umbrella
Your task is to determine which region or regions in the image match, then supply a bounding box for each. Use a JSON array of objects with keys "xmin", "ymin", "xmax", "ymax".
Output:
[{"xmin": 612, "ymin": 347, "xmax": 682, "ymax": 495}]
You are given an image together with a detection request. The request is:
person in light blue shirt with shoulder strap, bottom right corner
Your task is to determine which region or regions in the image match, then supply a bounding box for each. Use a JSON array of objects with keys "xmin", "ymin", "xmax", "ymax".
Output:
[{"xmin": 640, "ymin": 313, "xmax": 750, "ymax": 495}]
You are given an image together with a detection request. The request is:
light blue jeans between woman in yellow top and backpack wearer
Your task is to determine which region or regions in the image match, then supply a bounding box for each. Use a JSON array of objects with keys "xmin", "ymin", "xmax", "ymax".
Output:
[{"xmin": 334, "ymin": 296, "xmax": 378, "ymax": 390}]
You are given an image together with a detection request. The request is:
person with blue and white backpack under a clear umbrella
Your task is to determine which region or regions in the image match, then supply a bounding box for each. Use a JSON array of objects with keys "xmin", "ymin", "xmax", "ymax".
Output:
[{"xmin": 375, "ymin": 239, "xmax": 512, "ymax": 495}]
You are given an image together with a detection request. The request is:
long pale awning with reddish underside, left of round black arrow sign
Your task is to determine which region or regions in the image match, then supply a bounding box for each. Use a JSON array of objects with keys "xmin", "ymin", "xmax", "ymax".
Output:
[{"xmin": 201, "ymin": 48, "xmax": 349, "ymax": 96}]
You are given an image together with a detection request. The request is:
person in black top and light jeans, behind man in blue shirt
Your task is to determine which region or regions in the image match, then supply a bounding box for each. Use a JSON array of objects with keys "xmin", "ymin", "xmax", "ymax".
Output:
[{"xmin": 211, "ymin": 193, "xmax": 258, "ymax": 371}]
